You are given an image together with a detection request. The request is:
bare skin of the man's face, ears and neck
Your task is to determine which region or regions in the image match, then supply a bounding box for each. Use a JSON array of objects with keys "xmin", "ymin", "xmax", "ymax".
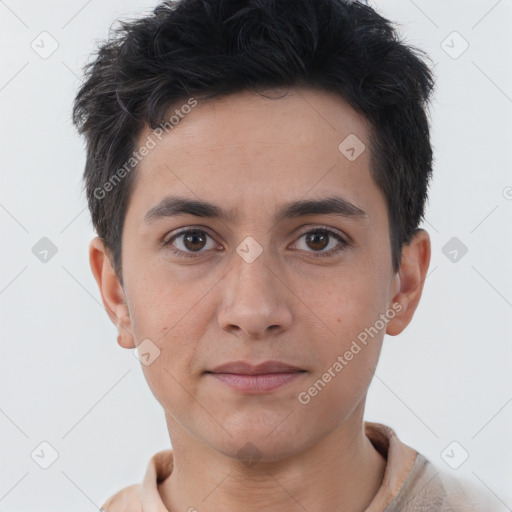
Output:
[{"xmin": 90, "ymin": 89, "xmax": 430, "ymax": 512}]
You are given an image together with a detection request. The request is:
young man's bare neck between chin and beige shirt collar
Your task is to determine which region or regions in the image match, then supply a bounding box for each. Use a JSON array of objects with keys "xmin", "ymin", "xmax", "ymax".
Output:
[{"xmin": 159, "ymin": 406, "xmax": 386, "ymax": 512}]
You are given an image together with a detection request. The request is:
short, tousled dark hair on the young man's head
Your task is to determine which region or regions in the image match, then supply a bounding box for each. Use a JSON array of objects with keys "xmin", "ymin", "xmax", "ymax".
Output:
[{"xmin": 73, "ymin": 0, "xmax": 434, "ymax": 284}]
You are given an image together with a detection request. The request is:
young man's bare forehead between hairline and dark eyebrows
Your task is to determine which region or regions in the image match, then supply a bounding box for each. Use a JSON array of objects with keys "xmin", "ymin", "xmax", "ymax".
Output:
[{"xmin": 130, "ymin": 89, "xmax": 380, "ymax": 226}]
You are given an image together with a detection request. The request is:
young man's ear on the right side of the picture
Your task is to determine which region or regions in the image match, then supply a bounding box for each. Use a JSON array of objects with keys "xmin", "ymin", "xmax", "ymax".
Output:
[{"xmin": 386, "ymin": 229, "xmax": 430, "ymax": 336}]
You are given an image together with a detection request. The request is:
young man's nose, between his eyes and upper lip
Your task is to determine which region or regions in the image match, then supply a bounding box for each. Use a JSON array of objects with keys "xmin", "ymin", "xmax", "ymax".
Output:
[{"xmin": 218, "ymin": 251, "xmax": 292, "ymax": 339}]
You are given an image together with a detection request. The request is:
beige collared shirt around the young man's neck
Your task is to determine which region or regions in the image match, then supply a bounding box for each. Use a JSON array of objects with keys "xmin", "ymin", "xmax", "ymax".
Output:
[{"xmin": 102, "ymin": 422, "xmax": 495, "ymax": 512}]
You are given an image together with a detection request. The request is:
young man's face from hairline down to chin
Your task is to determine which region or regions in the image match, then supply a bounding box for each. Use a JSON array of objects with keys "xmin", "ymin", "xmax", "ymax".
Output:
[{"xmin": 91, "ymin": 89, "xmax": 429, "ymax": 460}]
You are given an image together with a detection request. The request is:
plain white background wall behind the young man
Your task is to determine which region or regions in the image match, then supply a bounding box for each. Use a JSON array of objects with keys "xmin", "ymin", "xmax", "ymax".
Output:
[{"xmin": 0, "ymin": 0, "xmax": 512, "ymax": 512}]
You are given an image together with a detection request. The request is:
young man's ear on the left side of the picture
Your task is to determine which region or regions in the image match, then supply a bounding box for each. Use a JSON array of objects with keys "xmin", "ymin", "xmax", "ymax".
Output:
[{"xmin": 89, "ymin": 237, "xmax": 135, "ymax": 348}]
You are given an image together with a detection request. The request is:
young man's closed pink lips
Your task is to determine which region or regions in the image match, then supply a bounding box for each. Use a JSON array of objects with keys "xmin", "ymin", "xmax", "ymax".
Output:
[{"xmin": 205, "ymin": 361, "xmax": 307, "ymax": 395}]
